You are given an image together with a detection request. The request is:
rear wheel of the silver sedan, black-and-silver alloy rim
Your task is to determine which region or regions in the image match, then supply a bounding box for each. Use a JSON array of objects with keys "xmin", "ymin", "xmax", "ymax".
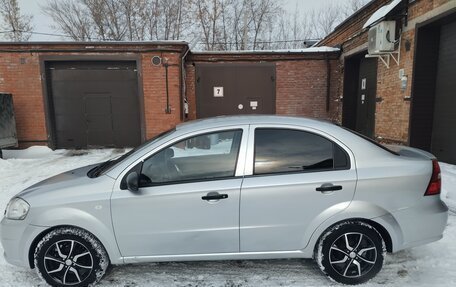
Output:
[{"xmin": 315, "ymin": 221, "xmax": 386, "ymax": 285}]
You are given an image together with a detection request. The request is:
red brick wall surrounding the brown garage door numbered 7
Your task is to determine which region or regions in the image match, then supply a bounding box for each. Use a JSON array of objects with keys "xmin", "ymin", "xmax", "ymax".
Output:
[{"xmin": 186, "ymin": 52, "xmax": 340, "ymax": 122}]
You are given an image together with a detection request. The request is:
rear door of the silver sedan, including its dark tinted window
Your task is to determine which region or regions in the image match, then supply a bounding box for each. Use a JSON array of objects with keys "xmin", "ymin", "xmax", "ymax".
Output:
[{"xmin": 240, "ymin": 125, "xmax": 356, "ymax": 252}]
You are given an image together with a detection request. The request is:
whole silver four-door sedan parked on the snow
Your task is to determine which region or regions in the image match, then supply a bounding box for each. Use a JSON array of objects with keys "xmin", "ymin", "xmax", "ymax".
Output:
[{"xmin": 1, "ymin": 116, "xmax": 448, "ymax": 286}]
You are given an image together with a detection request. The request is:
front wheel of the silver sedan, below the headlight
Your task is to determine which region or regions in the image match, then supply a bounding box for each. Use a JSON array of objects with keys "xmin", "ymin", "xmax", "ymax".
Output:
[{"xmin": 34, "ymin": 227, "xmax": 110, "ymax": 287}]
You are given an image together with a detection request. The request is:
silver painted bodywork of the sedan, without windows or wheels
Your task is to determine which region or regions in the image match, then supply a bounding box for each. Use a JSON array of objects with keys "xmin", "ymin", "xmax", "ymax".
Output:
[{"xmin": 1, "ymin": 116, "xmax": 448, "ymax": 286}]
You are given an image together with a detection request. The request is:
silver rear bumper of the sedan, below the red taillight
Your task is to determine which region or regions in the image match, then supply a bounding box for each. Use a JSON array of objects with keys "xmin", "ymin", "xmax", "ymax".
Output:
[{"xmin": 378, "ymin": 196, "xmax": 448, "ymax": 252}]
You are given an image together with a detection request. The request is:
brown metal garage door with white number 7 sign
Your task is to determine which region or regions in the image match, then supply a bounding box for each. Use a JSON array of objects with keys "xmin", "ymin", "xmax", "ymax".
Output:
[{"xmin": 196, "ymin": 63, "xmax": 275, "ymax": 118}]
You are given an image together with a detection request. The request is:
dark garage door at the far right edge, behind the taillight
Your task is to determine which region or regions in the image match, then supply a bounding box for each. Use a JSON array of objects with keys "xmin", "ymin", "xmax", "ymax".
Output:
[{"xmin": 431, "ymin": 21, "xmax": 456, "ymax": 163}]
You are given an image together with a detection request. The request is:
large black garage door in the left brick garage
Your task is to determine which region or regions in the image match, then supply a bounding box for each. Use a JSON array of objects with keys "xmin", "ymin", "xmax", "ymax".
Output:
[{"xmin": 46, "ymin": 62, "xmax": 141, "ymax": 148}]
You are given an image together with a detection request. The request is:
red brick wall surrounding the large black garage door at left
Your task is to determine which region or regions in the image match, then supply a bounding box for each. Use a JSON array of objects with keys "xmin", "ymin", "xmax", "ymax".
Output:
[{"xmin": 0, "ymin": 43, "xmax": 187, "ymax": 147}]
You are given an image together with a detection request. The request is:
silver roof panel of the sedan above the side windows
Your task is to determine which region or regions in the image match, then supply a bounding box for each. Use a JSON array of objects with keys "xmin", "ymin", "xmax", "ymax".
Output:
[{"xmin": 176, "ymin": 115, "xmax": 334, "ymax": 131}]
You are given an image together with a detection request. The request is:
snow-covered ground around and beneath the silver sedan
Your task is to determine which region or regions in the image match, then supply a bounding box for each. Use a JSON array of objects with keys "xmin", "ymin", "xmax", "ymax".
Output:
[{"xmin": 0, "ymin": 147, "xmax": 456, "ymax": 287}]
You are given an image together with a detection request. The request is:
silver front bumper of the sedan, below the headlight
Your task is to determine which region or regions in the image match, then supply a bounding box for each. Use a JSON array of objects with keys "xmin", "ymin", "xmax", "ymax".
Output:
[{"xmin": 0, "ymin": 218, "xmax": 47, "ymax": 268}]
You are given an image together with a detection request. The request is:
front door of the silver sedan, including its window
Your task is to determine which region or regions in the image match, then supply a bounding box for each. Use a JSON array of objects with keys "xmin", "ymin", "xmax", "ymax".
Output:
[{"xmin": 111, "ymin": 127, "xmax": 247, "ymax": 257}]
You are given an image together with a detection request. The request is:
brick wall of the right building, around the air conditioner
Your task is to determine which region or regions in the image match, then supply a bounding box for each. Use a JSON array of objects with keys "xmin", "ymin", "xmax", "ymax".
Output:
[{"xmin": 319, "ymin": 0, "xmax": 454, "ymax": 144}]
